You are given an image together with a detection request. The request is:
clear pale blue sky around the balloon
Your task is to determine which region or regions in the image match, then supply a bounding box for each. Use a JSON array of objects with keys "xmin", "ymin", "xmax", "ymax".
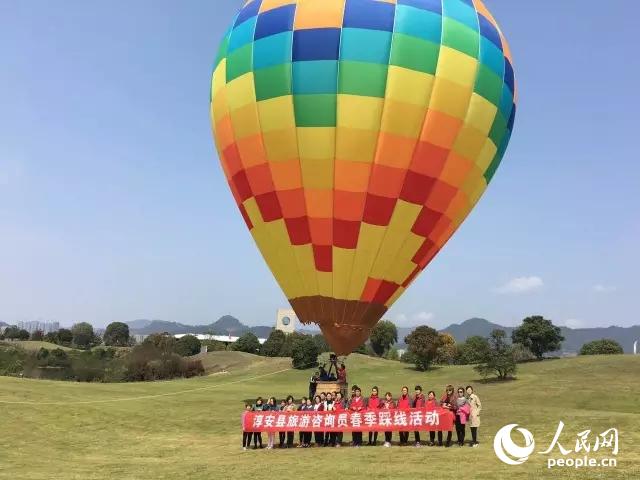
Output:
[{"xmin": 0, "ymin": 0, "xmax": 640, "ymax": 327}]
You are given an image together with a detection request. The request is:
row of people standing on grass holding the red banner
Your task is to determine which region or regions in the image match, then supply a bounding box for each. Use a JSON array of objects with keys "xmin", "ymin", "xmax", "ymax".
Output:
[{"xmin": 242, "ymin": 385, "xmax": 482, "ymax": 450}]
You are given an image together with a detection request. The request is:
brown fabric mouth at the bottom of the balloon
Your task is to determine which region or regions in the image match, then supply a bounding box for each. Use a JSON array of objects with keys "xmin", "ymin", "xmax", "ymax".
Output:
[{"xmin": 289, "ymin": 295, "xmax": 387, "ymax": 355}]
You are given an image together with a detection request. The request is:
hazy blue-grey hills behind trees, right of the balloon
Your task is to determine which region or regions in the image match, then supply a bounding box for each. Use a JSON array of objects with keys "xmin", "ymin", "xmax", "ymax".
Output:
[{"xmin": 432, "ymin": 318, "xmax": 640, "ymax": 353}]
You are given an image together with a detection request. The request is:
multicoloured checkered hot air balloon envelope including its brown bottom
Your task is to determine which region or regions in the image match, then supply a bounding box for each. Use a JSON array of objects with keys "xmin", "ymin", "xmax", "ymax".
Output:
[{"xmin": 210, "ymin": 0, "xmax": 516, "ymax": 355}]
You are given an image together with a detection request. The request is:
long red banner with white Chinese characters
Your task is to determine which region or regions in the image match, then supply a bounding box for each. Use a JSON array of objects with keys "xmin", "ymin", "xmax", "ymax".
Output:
[{"xmin": 242, "ymin": 408, "xmax": 454, "ymax": 432}]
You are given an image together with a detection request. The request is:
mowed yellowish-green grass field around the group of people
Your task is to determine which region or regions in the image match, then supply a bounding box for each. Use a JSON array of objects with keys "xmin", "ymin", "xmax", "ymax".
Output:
[{"xmin": 0, "ymin": 352, "xmax": 640, "ymax": 480}]
